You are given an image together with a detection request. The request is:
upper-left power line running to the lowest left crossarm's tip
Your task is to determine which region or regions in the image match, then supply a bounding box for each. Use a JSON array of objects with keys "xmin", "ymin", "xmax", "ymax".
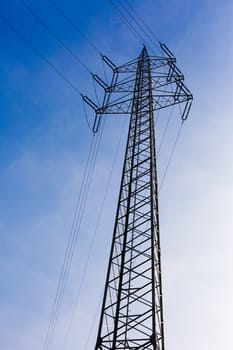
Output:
[{"xmin": 0, "ymin": 15, "xmax": 81, "ymax": 95}]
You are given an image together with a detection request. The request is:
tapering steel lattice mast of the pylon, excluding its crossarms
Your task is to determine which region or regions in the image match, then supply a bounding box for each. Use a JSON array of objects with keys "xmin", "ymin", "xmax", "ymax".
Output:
[{"xmin": 95, "ymin": 47, "xmax": 164, "ymax": 350}]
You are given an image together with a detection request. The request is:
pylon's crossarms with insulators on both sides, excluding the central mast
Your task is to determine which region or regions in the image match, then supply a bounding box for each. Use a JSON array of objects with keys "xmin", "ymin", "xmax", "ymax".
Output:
[{"xmin": 82, "ymin": 44, "xmax": 193, "ymax": 132}]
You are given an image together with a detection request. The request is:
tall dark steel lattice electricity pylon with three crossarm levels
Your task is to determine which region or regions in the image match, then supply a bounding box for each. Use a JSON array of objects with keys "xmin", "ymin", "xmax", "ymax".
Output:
[{"xmin": 83, "ymin": 44, "xmax": 192, "ymax": 350}]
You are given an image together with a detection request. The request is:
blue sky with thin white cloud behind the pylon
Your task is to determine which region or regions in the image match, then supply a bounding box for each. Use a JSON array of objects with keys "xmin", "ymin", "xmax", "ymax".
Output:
[{"xmin": 0, "ymin": 0, "xmax": 233, "ymax": 350}]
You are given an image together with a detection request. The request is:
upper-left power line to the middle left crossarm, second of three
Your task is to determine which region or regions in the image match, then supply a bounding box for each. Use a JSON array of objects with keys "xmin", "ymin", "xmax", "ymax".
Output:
[{"xmin": 19, "ymin": 0, "xmax": 91, "ymax": 73}]
